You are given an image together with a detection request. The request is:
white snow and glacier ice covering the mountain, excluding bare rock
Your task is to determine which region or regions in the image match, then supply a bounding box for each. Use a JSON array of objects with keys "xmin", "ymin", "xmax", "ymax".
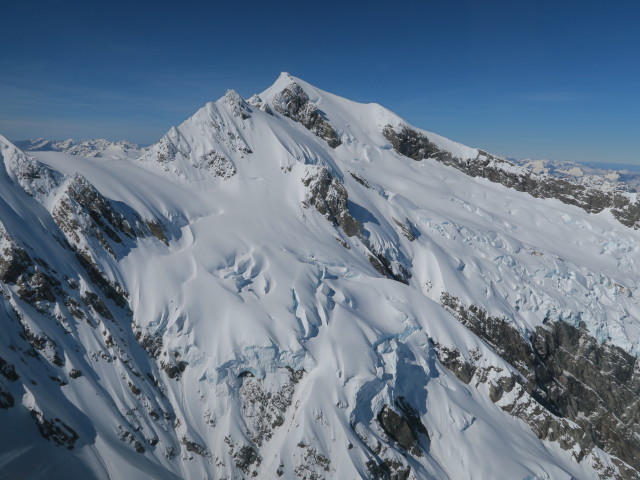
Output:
[{"xmin": 0, "ymin": 74, "xmax": 640, "ymax": 480}]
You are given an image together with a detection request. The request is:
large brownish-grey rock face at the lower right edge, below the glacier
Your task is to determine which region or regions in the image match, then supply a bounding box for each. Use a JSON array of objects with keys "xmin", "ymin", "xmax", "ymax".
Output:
[{"xmin": 441, "ymin": 293, "xmax": 640, "ymax": 478}]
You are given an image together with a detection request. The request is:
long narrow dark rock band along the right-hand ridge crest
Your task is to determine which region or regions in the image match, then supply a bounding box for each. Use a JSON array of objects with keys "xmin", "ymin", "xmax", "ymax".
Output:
[{"xmin": 382, "ymin": 125, "xmax": 640, "ymax": 228}]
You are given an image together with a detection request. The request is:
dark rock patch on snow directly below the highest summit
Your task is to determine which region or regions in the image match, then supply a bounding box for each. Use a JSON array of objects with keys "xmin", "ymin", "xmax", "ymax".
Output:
[{"xmin": 273, "ymin": 82, "xmax": 342, "ymax": 148}]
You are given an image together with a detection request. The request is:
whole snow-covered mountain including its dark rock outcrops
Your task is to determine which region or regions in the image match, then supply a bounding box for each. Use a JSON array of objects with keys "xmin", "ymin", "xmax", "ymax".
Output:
[{"xmin": 0, "ymin": 74, "xmax": 640, "ymax": 480}]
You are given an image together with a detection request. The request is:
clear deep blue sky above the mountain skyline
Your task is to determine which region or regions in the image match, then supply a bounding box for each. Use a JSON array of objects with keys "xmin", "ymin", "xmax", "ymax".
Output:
[{"xmin": 0, "ymin": 0, "xmax": 640, "ymax": 164}]
